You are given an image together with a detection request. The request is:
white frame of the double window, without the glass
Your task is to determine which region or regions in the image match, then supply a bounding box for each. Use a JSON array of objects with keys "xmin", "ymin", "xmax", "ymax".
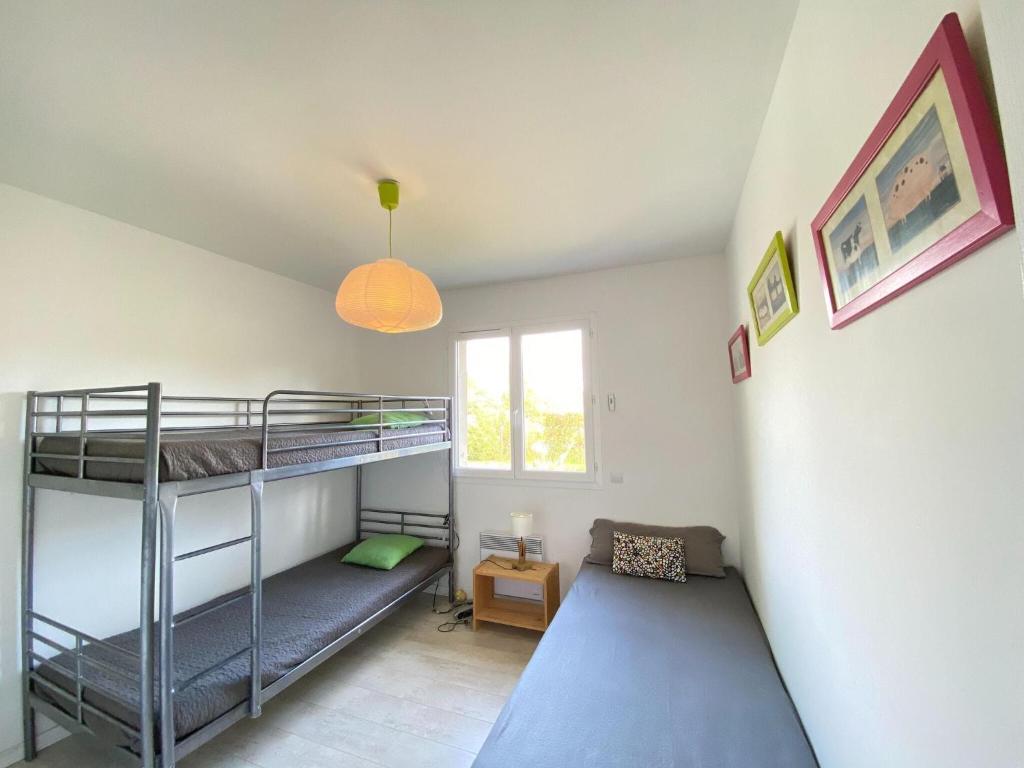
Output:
[{"xmin": 449, "ymin": 316, "xmax": 600, "ymax": 487}]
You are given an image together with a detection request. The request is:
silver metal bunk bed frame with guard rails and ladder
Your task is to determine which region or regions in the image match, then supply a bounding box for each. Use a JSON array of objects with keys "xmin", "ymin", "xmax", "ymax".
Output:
[{"xmin": 22, "ymin": 383, "xmax": 456, "ymax": 768}]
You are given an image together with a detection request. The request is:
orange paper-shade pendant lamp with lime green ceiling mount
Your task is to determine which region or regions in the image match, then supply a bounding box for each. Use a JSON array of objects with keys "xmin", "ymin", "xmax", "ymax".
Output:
[{"xmin": 334, "ymin": 179, "xmax": 441, "ymax": 334}]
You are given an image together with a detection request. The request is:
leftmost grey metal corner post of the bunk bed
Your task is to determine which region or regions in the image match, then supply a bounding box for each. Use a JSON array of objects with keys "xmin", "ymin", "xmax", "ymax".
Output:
[{"xmin": 22, "ymin": 392, "xmax": 36, "ymax": 761}]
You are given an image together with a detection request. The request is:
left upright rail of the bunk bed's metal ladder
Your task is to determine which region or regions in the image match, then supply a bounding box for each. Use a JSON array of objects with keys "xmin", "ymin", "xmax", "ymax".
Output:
[{"xmin": 159, "ymin": 483, "xmax": 178, "ymax": 768}]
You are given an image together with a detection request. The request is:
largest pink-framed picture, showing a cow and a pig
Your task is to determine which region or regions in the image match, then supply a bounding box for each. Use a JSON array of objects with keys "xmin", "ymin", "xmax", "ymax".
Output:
[{"xmin": 811, "ymin": 13, "xmax": 1013, "ymax": 329}]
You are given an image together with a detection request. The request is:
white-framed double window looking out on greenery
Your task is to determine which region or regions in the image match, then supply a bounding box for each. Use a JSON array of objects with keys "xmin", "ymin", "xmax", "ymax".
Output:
[{"xmin": 454, "ymin": 321, "xmax": 597, "ymax": 481}]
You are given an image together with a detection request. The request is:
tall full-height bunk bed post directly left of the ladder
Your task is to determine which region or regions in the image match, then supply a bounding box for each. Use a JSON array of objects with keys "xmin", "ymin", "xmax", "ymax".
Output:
[{"xmin": 138, "ymin": 383, "xmax": 161, "ymax": 768}]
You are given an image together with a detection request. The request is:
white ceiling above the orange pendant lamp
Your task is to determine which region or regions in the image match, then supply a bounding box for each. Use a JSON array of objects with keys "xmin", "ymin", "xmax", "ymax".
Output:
[{"xmin": 0, "ymin": 0, "xmax": 797, "ymax": 290}]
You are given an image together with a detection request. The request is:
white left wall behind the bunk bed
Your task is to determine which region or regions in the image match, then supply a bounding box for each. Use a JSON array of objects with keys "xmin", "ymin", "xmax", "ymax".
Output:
[{"xmin": 0, "ymin": 185, "xmax": 359, "ymax": 764}]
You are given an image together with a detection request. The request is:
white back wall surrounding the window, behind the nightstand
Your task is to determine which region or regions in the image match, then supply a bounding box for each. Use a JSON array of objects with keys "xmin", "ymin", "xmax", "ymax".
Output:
[{"xmin": 359, "ymin": 256, "xmax": 739, "ymax": 606}]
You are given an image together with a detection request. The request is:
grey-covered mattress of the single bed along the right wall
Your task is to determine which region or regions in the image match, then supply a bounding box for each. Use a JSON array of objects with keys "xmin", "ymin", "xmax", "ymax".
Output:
[{"xmin": 473, "ymin": 563, "xmax": 817, "ymax": 768}]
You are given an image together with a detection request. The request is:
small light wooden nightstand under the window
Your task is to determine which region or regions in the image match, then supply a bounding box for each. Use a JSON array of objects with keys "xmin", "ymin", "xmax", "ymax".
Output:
[{"xmin": 473, "ymin": 557, "xmax": 561, "ymax": 632}]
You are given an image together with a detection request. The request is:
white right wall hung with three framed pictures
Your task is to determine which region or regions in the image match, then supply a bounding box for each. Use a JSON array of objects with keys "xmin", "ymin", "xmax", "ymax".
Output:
[{"xmin": 728, "ymin": 0, "xmax": 1024, "ymax": 768}]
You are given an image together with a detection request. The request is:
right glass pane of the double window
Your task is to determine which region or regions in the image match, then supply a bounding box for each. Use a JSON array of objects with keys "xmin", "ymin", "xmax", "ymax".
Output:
[{"xmin": 521, "ymin": 329, "xmax": 587, "ymax": 472}]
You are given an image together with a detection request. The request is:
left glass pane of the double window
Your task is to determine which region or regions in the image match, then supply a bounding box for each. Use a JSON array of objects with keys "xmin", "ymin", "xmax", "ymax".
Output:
[{"xmin": 459, "ymin": 336, "xmax": 512, "ymax": 470}]
